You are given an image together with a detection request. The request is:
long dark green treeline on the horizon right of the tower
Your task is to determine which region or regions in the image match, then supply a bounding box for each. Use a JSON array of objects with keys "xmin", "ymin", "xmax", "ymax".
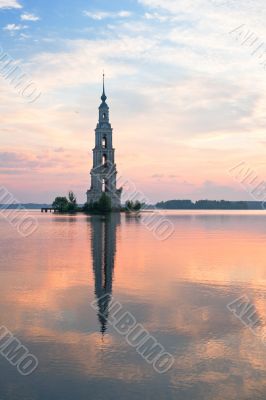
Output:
[{"xmin": 156, "ymin": 200, "xmax": 266, "ymax": 210}]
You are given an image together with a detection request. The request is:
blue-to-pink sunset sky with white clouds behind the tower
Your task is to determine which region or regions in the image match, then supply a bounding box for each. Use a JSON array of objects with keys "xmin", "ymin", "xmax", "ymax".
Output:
[{"xmin": 0, "ymin": 0, "xmax": 266, "ymax": 203}]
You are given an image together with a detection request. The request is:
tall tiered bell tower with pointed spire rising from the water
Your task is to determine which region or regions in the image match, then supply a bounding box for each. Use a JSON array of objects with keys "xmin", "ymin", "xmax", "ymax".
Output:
[{"xmin": 87, "ymin": 74, "xmax": 122, "ymax": 210}]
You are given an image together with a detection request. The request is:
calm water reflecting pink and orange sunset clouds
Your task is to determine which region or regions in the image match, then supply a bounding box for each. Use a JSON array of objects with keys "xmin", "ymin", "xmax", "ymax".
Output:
[{"xmin": 0, "ymin": 211, "xmax": 266, "ymax": 400}]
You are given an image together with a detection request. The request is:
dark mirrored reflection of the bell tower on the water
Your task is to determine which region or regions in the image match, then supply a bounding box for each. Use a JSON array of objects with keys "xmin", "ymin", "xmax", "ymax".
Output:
[{"xmin": 91, "ymin": 213, "xmax": 120, "ymax": 334}]
